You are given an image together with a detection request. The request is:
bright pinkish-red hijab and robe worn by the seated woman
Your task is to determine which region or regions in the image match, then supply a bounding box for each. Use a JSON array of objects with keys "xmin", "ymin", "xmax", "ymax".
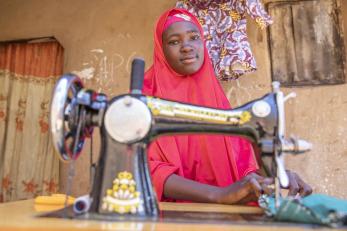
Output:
[{"xmin": 143, "ymin": 9, "xmax": 258, "ymax": 201}]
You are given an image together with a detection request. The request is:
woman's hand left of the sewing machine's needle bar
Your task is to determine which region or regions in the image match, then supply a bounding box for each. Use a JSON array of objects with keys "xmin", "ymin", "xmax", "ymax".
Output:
[{"xmin": 216, "ymin": 173, "xmax": 274, "ymax": 204}]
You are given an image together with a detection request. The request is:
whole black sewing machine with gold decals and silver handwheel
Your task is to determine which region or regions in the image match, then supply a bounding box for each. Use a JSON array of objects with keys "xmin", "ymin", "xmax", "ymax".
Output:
[{"xmin": 51, "ymin": 59, "xmax": 311, "ymax": 220}]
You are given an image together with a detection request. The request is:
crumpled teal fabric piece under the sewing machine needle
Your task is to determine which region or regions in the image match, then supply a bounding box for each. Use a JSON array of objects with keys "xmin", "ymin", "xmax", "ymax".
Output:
[{"xmin": 259, "ymin": 194, "xmax": 347, "ymax": 227}]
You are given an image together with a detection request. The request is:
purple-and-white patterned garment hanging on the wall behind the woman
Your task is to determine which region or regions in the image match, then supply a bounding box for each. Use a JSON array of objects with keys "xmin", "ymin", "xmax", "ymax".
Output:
[{"xmin": 176, "ymin": 0, "xmax": 272, "ymax": 80}]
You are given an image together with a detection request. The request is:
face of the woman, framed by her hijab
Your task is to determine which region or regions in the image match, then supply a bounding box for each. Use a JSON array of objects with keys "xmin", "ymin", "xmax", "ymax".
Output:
[{"xmin": 162, "ymin": 21, "xmax": 204, "ymax": 75}]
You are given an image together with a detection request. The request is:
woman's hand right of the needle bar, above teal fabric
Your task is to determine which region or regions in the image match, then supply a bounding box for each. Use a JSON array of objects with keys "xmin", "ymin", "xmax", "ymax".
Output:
[{"xmin": 286, "ymin": 170, "xmax": 312, "ymax": 197}]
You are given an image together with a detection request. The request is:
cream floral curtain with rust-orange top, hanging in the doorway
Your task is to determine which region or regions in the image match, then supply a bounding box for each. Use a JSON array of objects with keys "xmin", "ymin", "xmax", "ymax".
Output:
[{"xmin": 0, "ymin": 41, "xmax": 63, "ymax": 202}]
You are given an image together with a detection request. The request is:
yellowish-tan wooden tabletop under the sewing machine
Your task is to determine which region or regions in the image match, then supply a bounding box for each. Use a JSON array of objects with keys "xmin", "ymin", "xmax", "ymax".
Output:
[{"xmin": 0, "ymin": 200, "xmax": 347, "ymax": 231}]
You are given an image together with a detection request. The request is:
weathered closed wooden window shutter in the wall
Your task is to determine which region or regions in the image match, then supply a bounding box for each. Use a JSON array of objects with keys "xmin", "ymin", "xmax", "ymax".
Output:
[{"xmin": 267, "ymin": 0, "xmax": 345, "ymax": 87}]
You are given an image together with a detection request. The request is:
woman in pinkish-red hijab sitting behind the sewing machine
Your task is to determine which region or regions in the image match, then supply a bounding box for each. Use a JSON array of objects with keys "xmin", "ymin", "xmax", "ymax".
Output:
[{"xmin": 143, "ymin": 9, "xmax": 311, "ymax": 204}]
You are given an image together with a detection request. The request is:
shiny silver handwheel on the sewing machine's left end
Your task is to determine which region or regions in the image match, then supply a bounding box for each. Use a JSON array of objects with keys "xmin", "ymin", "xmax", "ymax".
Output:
[{"xmin": 50, "ymin": 74, "xmax": 85, "ymax": 161}]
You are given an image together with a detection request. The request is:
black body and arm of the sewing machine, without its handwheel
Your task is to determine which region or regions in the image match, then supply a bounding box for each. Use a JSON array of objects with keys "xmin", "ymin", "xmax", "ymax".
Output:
[{"xmin": 91, "ymin": 94, "xmax": 277, "ymax": 216}]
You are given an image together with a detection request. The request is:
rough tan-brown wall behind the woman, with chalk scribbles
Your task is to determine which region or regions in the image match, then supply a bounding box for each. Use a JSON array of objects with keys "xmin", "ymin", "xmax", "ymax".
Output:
[{"xmin": 0, "ymin": 0, "xmax": 347, "ymax": 198}]
